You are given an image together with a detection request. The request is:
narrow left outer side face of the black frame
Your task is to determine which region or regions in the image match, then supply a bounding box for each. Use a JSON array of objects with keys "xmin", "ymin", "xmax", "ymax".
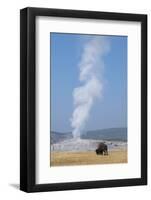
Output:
[{"xmin": 20, "ymin": 8, "xmax": 28, "ymax": 191}]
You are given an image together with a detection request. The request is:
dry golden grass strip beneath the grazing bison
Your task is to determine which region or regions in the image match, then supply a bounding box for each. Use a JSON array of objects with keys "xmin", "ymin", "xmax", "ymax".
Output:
[{"xmin": 50, "ymin": 150, "xmax": 127, "ymax": 166}]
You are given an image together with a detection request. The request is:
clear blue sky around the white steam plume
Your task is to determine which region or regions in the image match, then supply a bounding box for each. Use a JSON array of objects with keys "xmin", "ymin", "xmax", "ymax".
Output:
[{"xmin": 50, "ymin": 33, "xmax": 127, "ymax": 132}]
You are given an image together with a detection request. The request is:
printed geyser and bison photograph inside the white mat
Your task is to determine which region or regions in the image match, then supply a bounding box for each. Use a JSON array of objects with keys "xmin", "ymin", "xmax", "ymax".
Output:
[{"xmin": 49, "ymin": 32, "xmax": 128, "ymax": 167}]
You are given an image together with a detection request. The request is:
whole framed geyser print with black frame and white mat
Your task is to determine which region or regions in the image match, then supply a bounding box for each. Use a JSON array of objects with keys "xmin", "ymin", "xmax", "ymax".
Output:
[{"xmin": 20, "ymin": 8, "xmax": 147, "ymax": 192}]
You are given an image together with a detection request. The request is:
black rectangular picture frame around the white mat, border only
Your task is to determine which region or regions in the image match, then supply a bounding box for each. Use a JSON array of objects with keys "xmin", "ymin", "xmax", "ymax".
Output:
[{"xmin": 20, "ymin": 7, "xmax": 147, "ymax": 192}]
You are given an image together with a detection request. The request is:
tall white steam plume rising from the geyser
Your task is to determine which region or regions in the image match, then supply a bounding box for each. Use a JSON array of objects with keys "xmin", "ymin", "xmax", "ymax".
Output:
[{"xmin": 71, "ymin": 36, "xmax": 110, "ymax": 138}]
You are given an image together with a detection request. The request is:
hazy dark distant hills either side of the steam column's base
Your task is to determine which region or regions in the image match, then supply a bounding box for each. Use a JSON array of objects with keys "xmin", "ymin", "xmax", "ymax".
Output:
[{"xmin": 50, "ymin": 128, "xmax": 127, "ymax": 144}]
